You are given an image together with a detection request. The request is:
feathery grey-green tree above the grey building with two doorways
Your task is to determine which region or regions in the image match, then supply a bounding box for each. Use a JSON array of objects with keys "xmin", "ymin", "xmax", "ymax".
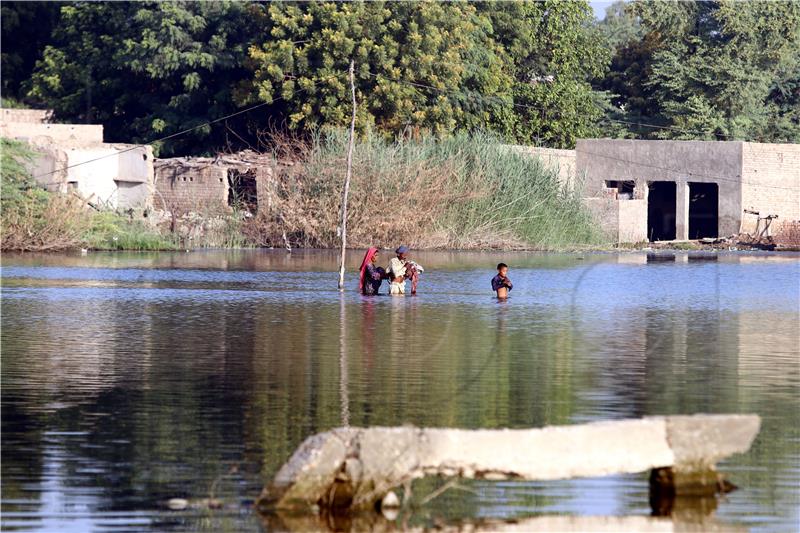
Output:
[{"xmin": 601, "ymin": 0, "xmax": 800, "ymax": 142}]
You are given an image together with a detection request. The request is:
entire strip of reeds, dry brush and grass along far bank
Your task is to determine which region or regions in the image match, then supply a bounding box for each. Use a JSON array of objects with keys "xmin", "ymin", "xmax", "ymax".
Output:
[{"xmin": 2, "ymin": 129, "xmax": 602, "ymax": 250}]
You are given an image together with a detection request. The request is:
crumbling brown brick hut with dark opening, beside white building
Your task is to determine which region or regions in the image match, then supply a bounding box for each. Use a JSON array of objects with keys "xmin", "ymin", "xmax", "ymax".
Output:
[{"xmin": 155, "ymin": 151, "xmax": 275, "ymax": 215}]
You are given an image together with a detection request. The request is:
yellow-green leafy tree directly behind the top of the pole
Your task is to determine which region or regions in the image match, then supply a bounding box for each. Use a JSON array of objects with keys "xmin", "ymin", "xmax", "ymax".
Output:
[{"xmin": 238, "ymin": 2, "xmax": 511, "ymax": 133}]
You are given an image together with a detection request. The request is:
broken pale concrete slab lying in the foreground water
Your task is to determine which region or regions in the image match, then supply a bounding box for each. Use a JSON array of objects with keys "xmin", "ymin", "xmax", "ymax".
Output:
[{"xmin": 257, "ymin": 415, "xmax": 761, "ymax": 511}]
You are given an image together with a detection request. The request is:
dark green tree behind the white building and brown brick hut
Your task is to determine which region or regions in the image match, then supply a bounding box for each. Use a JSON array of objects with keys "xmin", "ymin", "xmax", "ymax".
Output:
[{"xmin": 30, "ymin": 2, "xmax": 259, "ymax": 154}]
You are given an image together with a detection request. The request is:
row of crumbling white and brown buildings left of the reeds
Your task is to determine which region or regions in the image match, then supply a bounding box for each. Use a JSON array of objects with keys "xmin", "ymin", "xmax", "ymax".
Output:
[{"xmin": 0, "ymin": 109, "xmax": 282, "ymax": 216}]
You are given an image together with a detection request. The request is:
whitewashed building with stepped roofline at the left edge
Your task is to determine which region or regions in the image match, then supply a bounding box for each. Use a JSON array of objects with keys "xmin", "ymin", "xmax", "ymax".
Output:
[{"xmin": 0, "ymin": 109, "xmax": 153, "ymax": 209}]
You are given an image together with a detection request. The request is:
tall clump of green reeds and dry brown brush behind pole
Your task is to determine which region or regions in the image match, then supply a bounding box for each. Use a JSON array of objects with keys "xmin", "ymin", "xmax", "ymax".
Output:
[{"xmin": 246, "ymin": 130, "xmax": 601, "ymax": 250}]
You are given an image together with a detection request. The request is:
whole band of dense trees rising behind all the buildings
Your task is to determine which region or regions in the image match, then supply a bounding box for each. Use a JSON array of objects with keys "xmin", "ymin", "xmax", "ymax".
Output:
[{"xmin": 2, "ymin": 0, "xmax": 800, "ymax": 155}]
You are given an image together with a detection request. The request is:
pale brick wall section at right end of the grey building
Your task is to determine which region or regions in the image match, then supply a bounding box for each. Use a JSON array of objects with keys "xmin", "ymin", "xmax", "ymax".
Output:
[{"xmin": 742, "ymin": 143, "xmax": 800, "ymax": 234}]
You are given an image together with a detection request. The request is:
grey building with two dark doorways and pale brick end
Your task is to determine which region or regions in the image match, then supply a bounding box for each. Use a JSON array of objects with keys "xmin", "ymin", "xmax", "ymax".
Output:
[{"xmin": 575, "ymin": 139, "xmax": 800, "ymax": 242}]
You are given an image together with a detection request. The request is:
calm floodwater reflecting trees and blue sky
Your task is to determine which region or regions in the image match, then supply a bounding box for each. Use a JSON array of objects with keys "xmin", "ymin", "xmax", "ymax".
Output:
[{"xmin": 2, "ymin": 251, "xmax": 800, "ymax": 531}]
